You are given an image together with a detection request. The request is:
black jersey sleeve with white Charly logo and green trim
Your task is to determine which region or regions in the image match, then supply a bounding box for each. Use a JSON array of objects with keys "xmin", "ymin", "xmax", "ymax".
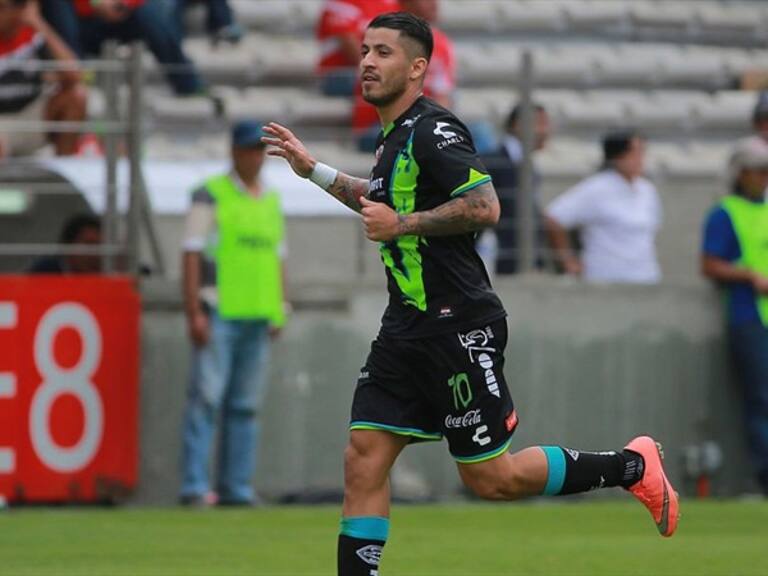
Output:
[{"xmin": 413, "ymin": 114, "xmax": 491, "ymax": 198}]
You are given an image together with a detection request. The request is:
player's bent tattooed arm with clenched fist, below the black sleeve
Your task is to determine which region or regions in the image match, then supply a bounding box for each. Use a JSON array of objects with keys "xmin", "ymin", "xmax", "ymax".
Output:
[{"xmin": 361, "ymin": 182, "xmax": 499, "ymax": 242}]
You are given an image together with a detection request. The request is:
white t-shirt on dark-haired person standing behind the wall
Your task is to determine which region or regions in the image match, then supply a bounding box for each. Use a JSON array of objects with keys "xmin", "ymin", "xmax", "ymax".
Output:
[{"xmin": 546, "ymin": 170, "xmax": 662, "ymax": 284}]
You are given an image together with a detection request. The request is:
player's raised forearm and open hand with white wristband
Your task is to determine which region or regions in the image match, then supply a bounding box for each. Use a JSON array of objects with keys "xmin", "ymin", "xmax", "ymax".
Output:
[{"xmin": 262, "ymin": 122, "xmax": 368, "ymax": 212}]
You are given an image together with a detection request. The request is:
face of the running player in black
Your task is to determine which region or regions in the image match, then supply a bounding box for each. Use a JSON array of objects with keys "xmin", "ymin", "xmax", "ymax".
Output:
[{"xmin": 360, "ymin": 28, "xmax": 412, "ymax": 107}]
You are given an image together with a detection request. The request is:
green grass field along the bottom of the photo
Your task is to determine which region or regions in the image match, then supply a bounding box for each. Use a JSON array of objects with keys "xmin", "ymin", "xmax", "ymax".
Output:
[{"xmin": 0, "ymin": 501, "xmax": 768, "ymax": 576}]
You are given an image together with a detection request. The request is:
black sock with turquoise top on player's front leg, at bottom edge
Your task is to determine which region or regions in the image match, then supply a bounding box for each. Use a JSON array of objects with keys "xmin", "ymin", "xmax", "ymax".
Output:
[{"xmin": 337, "ymin": 516, "xmax": 389, "ymax": 576}]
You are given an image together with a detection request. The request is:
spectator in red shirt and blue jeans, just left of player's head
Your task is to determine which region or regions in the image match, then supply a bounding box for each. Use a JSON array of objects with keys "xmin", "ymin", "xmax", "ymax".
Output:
[{"xmin": 317, "ymin": 0, "xmax": 399, "ymax": 96}]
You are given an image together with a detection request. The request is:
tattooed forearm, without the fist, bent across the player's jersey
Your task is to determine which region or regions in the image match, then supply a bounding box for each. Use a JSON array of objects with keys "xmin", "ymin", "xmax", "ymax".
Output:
[{"xmin": 399, "ymin": 182, "xmax": 499, "ymax": 236}]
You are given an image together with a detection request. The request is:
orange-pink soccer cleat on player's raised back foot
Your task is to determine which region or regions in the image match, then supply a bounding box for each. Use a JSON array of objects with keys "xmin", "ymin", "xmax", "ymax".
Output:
[{"xmin": 624, "ymin": 436, "xmax": 680, "ymax": 537}]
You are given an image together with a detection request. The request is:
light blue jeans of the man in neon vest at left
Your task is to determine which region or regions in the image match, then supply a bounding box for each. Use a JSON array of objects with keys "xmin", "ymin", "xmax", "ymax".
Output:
[{"xmin": 181, "ymin": 312, "xmax": 270, "ymax": 503}]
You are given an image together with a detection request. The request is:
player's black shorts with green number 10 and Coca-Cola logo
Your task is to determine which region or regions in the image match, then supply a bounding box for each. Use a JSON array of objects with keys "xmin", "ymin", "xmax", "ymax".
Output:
[{"xmin": 350, "ymin": 318, "xmax": 517, "ymax": 463}]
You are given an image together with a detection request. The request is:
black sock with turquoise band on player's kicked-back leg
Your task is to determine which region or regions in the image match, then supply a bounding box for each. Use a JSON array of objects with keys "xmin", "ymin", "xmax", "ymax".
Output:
[{"xmin": 542, "ymin": 446, "xmax": 644, "ymax": 495}]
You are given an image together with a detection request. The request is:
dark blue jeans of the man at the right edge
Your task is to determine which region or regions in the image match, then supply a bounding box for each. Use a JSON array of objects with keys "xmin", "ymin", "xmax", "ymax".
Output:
[{"xmin": 729, "ymin": 324, "xmax": 768, "ymax": 496}]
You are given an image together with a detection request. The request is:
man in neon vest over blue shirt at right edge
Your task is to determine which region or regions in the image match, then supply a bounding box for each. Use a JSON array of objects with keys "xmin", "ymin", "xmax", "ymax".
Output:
[{"xmin": 701, "ymin": 137, "xmax": 768, "ymax": 496}]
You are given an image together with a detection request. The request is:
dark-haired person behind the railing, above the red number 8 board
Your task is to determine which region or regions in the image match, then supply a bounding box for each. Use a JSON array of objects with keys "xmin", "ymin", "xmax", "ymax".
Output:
[{"xmin": 29, "ymin": 214, "xmax": 102, "ymax": 274}]
